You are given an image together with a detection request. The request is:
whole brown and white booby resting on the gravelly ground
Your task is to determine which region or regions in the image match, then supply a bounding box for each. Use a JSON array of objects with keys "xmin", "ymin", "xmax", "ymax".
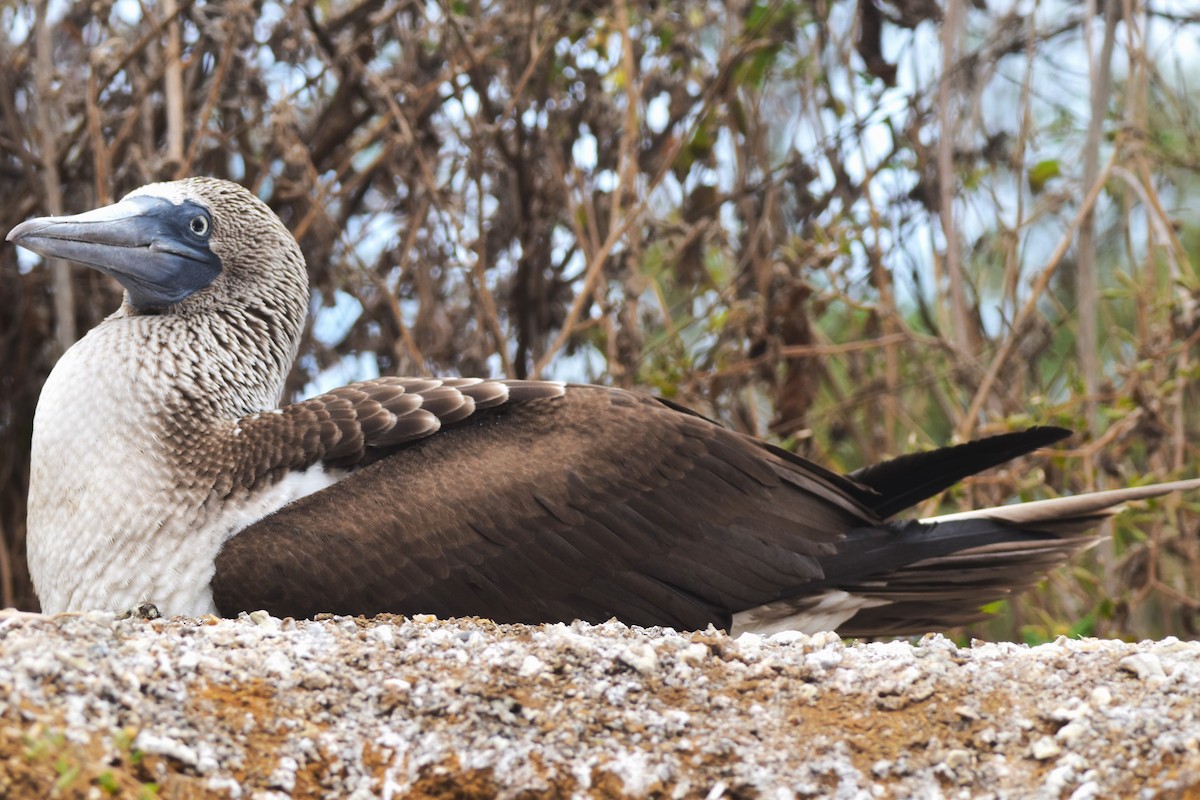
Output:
[{"xmin": 7, "ymin": 178, "xmax": 1200, "ymax": 636}]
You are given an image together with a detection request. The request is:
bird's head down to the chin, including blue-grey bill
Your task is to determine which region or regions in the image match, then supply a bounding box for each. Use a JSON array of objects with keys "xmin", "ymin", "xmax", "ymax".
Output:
[{"xmin": 7, "ymin": 178, "xmax": 308, "ymax": 325}]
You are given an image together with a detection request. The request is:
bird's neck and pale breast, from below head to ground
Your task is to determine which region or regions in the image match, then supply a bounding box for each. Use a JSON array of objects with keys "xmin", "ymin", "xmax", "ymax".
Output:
[{"xmin": 28, "ymin": 297, "xmax": 307, "ymax": 614}]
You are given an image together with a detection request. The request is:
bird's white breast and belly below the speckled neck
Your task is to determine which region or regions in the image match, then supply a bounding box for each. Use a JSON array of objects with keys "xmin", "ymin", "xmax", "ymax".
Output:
[{"xmin": 28, "ymin": 329, "xmax": 344, "ymax": 615}]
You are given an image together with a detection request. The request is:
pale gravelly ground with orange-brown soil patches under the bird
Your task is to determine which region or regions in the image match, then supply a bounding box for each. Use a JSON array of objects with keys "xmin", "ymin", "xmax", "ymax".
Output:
[{"xmin": 0, "ymin": 612, "xmax": 1200, "ymax": 800}]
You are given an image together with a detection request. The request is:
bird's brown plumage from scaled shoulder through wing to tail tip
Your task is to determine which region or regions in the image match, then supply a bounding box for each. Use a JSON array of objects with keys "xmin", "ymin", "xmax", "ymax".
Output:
[{"xmin": 212, "ymin": 378, "xmax": 1200, "ymax": 634}]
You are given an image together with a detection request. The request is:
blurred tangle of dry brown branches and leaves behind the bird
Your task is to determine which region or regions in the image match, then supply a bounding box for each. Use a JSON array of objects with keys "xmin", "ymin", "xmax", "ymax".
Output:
[{"xmin": 0, "ymin": 0, "xmax": 1200, "ymax": 642}]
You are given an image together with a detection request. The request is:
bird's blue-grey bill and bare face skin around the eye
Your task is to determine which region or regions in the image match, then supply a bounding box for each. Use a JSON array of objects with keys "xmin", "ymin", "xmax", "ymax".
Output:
[{"xmin": 7, "ymin": 196, "xmax": 221, "ymax": 309}]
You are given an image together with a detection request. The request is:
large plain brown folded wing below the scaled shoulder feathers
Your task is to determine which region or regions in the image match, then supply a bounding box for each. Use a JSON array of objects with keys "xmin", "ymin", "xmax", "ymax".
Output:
[{"xmin": 212, "ymin": 384, "xmax": 872, "ymax": 628}]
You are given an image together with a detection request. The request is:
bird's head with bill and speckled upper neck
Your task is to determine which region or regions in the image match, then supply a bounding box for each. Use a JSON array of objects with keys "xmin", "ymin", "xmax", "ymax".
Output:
[{"xmin": 8, "ymin": 178, "xmax": 308, "ymax": 414}]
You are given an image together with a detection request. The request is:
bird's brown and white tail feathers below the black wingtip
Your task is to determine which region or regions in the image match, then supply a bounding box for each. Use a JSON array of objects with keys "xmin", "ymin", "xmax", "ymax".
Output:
[{"xmin": 734, "ymin": 480, "xmax": 1200, "ymax": 637}]
